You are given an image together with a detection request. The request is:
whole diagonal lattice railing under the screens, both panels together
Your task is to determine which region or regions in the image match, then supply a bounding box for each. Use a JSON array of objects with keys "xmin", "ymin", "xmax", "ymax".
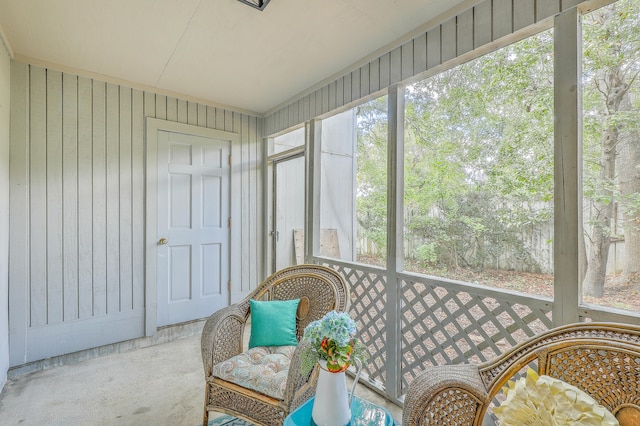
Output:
[{"xmin": 320, "ymin": 259, "xmax": 553, "ymax": 396}]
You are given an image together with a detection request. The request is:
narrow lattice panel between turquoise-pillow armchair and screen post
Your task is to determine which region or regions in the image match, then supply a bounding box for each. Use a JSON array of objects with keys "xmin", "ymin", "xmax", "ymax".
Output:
[{"xmin": 326, "ymin": 264, "xmax": 387, "ymax": 387}]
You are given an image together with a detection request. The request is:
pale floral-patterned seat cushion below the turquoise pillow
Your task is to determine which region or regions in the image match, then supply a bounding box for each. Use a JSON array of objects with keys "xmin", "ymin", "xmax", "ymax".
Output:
[{"xmin": 213, "ymin": 346, "xmax": 296, "ymax": 399}]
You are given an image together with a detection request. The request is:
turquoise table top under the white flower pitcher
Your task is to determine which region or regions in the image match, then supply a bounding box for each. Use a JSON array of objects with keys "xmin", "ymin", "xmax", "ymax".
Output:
[{"xmin": 284, "ymin": 396, "xmax": 395, "ymax": 426}]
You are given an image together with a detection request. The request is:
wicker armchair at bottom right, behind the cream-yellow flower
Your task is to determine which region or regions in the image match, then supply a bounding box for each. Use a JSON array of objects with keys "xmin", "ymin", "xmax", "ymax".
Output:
[{"xmin": 402, "ymin": 323, "xmax": 640, "ymax": 426}]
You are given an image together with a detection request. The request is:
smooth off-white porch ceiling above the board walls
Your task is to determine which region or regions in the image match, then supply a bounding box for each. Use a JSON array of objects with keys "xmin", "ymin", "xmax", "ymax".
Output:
[{"xmin": 0, "ymin": 0, "xmax": 469, "ymax": 114}]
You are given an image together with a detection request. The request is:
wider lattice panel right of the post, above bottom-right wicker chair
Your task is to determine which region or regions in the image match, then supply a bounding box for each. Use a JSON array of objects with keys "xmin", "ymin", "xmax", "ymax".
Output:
[{"xmin": 400, "ymin": 279, "xmax": 552, "ymax": 390}]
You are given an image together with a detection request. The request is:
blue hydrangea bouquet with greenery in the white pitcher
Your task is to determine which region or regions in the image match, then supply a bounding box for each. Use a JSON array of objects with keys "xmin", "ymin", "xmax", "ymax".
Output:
[{"xmin": 301, "ymin": 311, "xmax": 368, "ymax": 375}]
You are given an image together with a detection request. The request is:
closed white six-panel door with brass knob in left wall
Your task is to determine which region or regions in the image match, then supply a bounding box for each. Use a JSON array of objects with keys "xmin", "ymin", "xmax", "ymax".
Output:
[{"xmin": 157, "ymin": 131, "xmax": 231, "ymax": 326}]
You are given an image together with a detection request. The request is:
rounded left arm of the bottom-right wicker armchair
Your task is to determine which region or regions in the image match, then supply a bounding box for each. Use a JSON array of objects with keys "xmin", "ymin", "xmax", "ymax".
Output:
[{"xmin": 402, "ymin": 364, "xmax": 488, "ymax": 426}]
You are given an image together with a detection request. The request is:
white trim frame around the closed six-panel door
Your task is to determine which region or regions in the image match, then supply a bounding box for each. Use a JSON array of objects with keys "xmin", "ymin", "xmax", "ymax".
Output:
[{"xmin": 144, "ymin": 117, "xmax": 240, "ymax": 336}]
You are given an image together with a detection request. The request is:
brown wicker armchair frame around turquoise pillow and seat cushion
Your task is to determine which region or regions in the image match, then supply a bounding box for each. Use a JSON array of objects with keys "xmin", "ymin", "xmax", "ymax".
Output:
[{"xmin": 201, "ymin": 265, "xmax": 349, "ymax": 425}]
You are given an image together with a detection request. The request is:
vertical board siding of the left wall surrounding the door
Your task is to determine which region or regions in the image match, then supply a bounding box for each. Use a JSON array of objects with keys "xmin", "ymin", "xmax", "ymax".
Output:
[{"xmin": 10, "ymin": 63, "xmax": 262, "ymax": 365}]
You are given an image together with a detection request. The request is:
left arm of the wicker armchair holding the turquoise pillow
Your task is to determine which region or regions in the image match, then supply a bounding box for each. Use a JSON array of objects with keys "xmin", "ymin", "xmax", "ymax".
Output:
[{"xmin": 200, "ymin": 304, "xmax": 247, "ymax": 377}]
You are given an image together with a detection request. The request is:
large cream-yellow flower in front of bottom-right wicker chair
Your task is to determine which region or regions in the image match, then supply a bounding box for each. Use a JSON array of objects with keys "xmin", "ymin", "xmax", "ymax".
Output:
[{"xmin": 493, "ymin": 368, "xmax": 618, "ymax": 426}]
